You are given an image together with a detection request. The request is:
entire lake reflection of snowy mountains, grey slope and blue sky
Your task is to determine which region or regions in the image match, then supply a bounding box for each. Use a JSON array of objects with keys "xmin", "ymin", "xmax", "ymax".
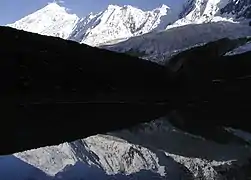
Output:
[{"xmin": 0, "ymin": 118, "xmax": 251, "ymax": 180}]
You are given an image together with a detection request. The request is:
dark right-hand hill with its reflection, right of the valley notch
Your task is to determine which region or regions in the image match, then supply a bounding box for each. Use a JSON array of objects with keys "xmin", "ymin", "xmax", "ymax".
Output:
[{"xmin": 166, "ymin": 37, "xmax": 251, "ymax": 140}]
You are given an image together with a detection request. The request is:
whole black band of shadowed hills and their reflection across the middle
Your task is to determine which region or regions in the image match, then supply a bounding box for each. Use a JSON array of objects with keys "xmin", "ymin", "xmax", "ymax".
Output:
[{"xmin": 0, "ymin": 27, "xmax": 251, "ymax": 154}]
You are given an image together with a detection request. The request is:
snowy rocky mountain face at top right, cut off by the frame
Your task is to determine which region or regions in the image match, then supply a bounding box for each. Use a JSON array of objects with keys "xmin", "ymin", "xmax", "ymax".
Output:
[{"xmin": 168, "ymin": 0, "xmax": 251, "ymax": 28}]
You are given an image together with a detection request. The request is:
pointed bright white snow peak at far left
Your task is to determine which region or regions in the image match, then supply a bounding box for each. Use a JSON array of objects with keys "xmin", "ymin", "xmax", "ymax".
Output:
[{"xmin": 7, "ymin": 3, "xmax": 79, "ymax": 39}]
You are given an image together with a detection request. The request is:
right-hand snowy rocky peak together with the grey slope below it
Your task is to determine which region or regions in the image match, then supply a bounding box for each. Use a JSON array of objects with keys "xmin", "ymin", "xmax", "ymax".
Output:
[{"xmin": 102, "ymin": 0, "xmax": 251, "ymax": 64}]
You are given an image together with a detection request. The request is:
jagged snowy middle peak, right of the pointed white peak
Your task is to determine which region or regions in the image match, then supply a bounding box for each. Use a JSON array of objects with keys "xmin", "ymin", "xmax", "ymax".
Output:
[{"xmin": 70, "ymin": 5, "xmax": 178, "ymax": 46}]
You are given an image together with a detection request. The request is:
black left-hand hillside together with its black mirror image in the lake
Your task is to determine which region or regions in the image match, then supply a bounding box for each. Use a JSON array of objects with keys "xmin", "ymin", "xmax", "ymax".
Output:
[{"xmin": 0, "ymin": 27, "xmax": 176, "ymax": 154}]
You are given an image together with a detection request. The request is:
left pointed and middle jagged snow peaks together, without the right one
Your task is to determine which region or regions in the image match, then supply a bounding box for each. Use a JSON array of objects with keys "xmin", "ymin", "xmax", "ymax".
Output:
[{"xmin": 7, "ymin": 2, "xmax": 178, "ymax": 46}]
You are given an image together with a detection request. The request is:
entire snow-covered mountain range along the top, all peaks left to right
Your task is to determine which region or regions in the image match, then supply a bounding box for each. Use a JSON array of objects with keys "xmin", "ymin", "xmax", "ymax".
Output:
[{"xmin": 7, "ymin": 0, "xmax": 251, "ymax": 46}]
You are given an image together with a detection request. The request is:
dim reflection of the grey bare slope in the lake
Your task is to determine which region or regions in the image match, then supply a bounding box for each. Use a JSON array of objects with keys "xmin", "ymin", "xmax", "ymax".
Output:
[{"xmin": 109, "ymin": 117, "xmax": 250, "ymax": 163}]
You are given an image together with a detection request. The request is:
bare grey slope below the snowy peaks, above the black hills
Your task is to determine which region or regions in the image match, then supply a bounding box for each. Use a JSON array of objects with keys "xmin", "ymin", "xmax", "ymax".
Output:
[{"xmin": 104, "ymin": 22, "xmax": 251, "ymax": 64}]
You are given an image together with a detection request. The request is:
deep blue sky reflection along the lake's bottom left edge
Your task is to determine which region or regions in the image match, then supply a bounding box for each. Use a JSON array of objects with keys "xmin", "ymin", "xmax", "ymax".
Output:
[{"xmin": 0, "ymin": 155, "xmax": 165, "ymax": 180}]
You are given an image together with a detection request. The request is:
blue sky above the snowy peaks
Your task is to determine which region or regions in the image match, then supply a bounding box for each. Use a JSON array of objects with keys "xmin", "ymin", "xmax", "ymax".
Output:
[{"xmin": 0, "ymin": 0, "xmax": 184, "ymax": 25}]
